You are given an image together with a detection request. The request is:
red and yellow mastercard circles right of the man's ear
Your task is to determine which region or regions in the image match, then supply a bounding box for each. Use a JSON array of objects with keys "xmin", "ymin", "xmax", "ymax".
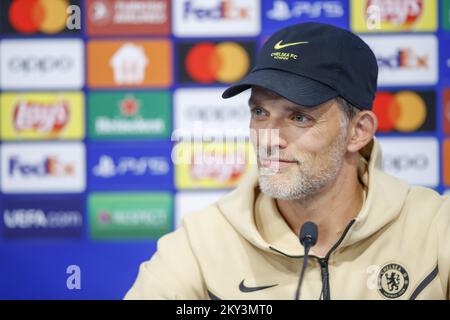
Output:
[{"xmin": 373, "ymin": 91, "xmax": 433, "ymax": 132}]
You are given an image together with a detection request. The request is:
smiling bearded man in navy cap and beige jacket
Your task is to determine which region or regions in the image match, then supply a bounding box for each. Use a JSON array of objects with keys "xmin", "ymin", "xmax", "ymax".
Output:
[{"xmin": 126, "ymin": 23, "xmax": 450, "ymax": 299}]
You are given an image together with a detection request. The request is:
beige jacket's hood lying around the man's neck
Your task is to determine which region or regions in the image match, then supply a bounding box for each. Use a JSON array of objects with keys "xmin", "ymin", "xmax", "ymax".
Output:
[{"xmin": 217, "ymin": 138, "xmax": 409, "ymax": 256}]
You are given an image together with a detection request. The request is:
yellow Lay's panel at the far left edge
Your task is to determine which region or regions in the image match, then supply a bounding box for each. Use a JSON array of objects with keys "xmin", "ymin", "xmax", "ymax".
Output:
[{"xmin": 0, "ymin": 92, "xmax": 84, "ymax": 140}]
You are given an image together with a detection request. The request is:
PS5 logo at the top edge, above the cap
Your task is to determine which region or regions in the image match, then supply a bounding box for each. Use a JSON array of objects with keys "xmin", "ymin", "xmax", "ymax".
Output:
[{"xmin": 267, "ymin": 0, "xmax": 344, "ymax": 21}]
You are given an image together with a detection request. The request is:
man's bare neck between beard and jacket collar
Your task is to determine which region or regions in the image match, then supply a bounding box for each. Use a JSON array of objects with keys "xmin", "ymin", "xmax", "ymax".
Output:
[{"xmin": 276, "ymin": 158, "xmax": 364, "ymax": 256}]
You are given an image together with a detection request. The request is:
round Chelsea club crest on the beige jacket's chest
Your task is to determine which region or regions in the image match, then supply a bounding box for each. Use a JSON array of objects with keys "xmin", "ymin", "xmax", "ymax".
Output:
[{"xmin": 378, "ymin": 263, "xmax": 409, "ymax": 299}]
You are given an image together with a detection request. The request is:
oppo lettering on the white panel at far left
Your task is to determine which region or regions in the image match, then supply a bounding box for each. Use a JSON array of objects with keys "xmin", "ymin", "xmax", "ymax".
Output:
[{"xmin": 8, "ymin": 56, "xmax": 73, "ymax": 72}]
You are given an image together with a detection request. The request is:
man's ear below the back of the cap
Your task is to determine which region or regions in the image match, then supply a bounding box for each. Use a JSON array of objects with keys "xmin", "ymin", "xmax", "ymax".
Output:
[{"xmin": 347, "ymin": 110, "xmax": 378, "ymax": 152}]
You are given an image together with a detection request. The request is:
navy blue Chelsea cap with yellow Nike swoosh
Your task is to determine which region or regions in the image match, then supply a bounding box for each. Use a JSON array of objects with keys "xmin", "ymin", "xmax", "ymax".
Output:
[{"xmin": 222, "ymin": 22, "xmax": 378, "ymax": 110}]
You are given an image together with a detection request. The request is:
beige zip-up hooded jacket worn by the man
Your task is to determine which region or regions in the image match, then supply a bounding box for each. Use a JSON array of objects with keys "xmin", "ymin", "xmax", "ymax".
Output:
[{"xmin": 125, "ymin": 139, "xmax": 450, "ymax": 300}]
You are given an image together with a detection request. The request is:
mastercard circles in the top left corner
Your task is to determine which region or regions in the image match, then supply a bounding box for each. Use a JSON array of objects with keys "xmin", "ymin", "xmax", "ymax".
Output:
[{"xmin": 8, "ymin": 0, "xmax": 70, "ymax": 34}]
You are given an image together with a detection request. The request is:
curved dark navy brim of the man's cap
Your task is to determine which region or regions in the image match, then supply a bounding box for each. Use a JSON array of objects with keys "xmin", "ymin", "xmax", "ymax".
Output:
[{"xmin": 222, "ymin": 69, "xmax": 339, "ymax": 107}]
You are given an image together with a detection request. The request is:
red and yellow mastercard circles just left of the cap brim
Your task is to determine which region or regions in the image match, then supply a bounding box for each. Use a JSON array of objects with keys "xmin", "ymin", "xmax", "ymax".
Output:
[{"xmin": 181, "ymin": 41, "xmax": 251, "ymax": 84}]
